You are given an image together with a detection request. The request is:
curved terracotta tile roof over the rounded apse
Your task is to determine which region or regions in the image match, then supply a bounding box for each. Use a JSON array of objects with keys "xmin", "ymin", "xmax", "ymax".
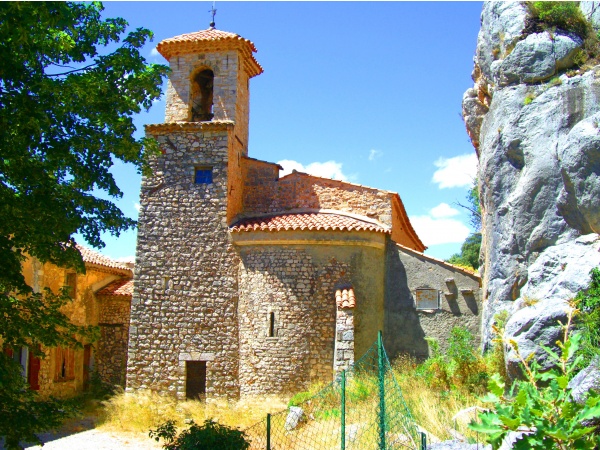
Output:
[{"xmin": 230, "ymin": 212, "xmax": 390, "ymax": 234}]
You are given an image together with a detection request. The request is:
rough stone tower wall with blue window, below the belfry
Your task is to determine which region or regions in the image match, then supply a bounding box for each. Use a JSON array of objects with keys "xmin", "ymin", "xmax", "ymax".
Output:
[{"xmin": 127, "ymin": 128, "xmax": 239, "ymax": 398}]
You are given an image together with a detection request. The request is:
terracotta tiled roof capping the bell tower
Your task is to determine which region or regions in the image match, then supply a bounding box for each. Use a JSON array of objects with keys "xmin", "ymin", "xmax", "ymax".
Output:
[{"xmin": 156, "ymin": 27, "xmax": 263, "ymax": 77}]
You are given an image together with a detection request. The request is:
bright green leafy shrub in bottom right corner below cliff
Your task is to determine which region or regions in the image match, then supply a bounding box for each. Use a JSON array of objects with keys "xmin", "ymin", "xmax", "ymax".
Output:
[{"xmin": 470, "ymin": 312, "xmax": 600, "ymax": 449}]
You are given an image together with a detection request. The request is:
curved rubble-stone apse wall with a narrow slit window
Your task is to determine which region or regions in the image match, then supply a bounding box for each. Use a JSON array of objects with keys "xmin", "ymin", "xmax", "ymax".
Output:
[{"xmin": 239, "ymin": 246, "xmax": 350, "ymax": 395}]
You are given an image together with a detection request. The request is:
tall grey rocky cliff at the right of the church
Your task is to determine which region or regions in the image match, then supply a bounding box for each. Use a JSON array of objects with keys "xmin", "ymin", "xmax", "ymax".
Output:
[{"xmin": 463, "ymin": 2, "xmax": 600, "ymax": 371}]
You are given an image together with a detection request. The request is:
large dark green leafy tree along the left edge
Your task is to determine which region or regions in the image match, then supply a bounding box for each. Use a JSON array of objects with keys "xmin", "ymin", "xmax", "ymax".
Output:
[{"xmin": 0, "ymin": 2, "xmax": 168, "ymax": 448}]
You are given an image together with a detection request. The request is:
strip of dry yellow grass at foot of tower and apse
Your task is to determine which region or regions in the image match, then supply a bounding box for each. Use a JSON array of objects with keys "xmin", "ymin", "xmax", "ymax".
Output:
[{"xmin": 99, "ymin": 391, "xmax": 287, "ymax": 432}]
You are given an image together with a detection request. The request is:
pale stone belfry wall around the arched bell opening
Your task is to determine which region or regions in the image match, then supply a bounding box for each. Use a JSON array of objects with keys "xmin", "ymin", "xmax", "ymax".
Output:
[{"xmin": 165, "ymin": 50, "xmax": 248, "ymax": 123}]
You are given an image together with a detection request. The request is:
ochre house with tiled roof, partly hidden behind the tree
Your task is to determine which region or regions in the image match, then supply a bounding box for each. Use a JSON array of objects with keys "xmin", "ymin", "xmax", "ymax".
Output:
[{"xmin": 9, "ymin": 247, "xmax": 133, "ymax": 397}]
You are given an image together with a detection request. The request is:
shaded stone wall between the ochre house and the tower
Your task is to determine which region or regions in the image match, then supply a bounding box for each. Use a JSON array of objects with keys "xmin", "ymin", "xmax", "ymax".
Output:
[{"xmin": 94, "ymin": 297, "xmax": 131, "ymax": 387}]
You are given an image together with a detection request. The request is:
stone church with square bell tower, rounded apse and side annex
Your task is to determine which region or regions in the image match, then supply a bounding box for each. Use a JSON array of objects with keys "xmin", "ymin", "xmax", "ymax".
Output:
[{"xmin": 127, "ymin": 27, "xmax": 479, "ymax": 398}]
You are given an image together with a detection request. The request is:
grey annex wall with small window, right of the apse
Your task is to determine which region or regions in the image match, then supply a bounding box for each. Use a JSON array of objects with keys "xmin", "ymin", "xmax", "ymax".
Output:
[{"xmin": 383, "ymin": 241, "xmax": 481, "ymax": 358}]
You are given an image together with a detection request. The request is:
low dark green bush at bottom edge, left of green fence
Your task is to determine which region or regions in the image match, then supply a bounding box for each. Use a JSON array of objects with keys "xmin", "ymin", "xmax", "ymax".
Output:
[{"xmin": 150, "ymin": 419, "xmax": 250, "ymax": 450}]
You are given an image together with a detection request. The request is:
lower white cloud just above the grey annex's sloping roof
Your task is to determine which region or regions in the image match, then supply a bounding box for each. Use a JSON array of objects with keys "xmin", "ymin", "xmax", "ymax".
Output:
[{"xmin": 410, "ymin": 203, "xmax": 471, "ymax": 246}]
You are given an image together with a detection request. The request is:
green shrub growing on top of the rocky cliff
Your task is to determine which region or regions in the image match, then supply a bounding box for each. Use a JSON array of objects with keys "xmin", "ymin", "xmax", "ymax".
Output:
[{"xmin": 529, "ymin": 2, "xmax": 593, "ymax": 39}]
